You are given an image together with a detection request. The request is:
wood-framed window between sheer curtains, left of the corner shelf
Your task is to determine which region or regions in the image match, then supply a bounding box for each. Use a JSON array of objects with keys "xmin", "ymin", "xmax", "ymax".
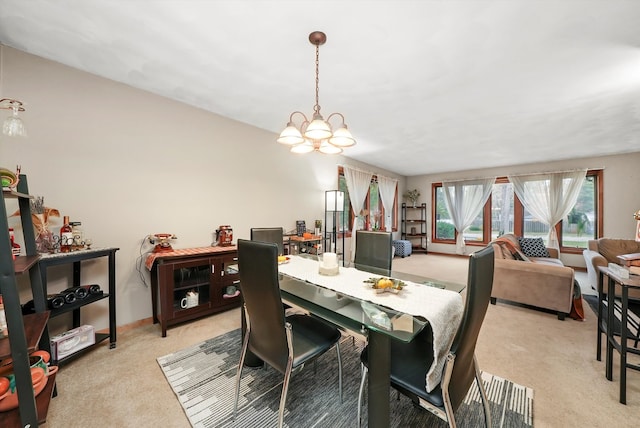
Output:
[{"xmin": 338, "ymin": 167, "xmax": 398, "ymax": 231}]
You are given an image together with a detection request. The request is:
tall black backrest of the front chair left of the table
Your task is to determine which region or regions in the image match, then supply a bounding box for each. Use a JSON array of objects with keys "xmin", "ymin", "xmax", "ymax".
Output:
[{"xmin": 238, "ymin": 239, "xmax": 289, "ymax": 373}]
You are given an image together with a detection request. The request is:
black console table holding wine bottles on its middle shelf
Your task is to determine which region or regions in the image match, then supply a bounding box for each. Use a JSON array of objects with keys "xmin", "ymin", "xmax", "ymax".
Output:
[{"xmin": 39, "ymin": 248, "xmax": 119, "ymax": 358}]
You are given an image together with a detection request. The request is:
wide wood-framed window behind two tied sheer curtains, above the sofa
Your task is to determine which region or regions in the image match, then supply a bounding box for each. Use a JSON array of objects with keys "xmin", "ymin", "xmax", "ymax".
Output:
[{"xmin": 432, "ymin": 170, "xmax": 603, "ymax": 254}]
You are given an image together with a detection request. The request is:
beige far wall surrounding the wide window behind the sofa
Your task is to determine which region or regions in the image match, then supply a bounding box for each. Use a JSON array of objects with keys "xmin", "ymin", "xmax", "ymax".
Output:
[{"xmin": 407, "ymin": 152, "xmax": 640, "ymax": 267}]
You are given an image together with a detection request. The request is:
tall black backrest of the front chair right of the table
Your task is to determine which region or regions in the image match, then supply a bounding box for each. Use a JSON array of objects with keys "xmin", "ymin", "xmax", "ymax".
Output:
[{"xmin": 449, "ymin": 246, "xmax": 494, "ymax": 409}]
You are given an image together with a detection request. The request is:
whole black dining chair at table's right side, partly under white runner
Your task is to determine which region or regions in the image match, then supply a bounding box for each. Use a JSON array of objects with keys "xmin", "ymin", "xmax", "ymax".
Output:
[{"xmin": 358, "ymin": 246, "xmax": 494, "ymax": 428}]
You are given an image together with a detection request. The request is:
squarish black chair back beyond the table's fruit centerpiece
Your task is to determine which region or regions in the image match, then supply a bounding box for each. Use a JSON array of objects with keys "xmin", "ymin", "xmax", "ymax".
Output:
[{"xmin": 354, "ymin": 230, "xmax": 393, "ymax": 275}]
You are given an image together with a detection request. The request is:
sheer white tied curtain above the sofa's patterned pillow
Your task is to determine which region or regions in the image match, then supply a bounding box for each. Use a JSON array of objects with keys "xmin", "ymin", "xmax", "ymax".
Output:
[{"xmin": 509, "ymin": 169, "xmax": 587, "ymax": 250}]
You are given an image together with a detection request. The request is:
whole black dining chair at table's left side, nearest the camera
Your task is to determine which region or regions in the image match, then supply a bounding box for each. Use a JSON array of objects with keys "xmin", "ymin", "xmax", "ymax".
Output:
[{"xmin": 233, "ymin": 239, "xmax": 342, "ymax": 427}]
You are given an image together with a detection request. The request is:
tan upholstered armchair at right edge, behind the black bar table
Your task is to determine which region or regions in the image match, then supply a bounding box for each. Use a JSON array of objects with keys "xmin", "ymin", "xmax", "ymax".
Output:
[{"xmin": 582, "ymin": 238, "xmax": 640, "ymax": 300}]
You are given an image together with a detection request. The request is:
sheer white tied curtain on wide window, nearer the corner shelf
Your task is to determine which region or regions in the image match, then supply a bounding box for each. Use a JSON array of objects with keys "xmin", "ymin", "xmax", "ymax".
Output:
[{"xmin": 442, "ymin": 178, "xmax": 496, "ymax": 254}]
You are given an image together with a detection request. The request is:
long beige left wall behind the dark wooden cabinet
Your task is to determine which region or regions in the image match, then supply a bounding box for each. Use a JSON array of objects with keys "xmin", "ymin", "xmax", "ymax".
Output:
[{"xmin": 0, "ymin": 46, "xmax": 404, "ymax": 329}]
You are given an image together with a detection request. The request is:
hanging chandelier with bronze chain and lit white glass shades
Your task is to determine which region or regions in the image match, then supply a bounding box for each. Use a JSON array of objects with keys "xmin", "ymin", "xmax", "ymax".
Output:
[{"xmin": 277, "ymin": 31, "xmax": 356, "ymax": 154}]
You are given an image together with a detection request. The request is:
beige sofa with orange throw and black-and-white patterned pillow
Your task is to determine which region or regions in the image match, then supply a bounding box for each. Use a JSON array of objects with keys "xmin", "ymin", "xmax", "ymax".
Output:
[{"xmin": 491, "ymin": 234, "xmax": 574, "ymax": 320}]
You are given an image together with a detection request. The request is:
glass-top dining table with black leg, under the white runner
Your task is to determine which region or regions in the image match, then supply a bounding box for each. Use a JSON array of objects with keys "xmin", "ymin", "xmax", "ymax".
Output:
[{"xmin": 280, "ymin": 255, "xmax": 466, "ymax": 428}]
